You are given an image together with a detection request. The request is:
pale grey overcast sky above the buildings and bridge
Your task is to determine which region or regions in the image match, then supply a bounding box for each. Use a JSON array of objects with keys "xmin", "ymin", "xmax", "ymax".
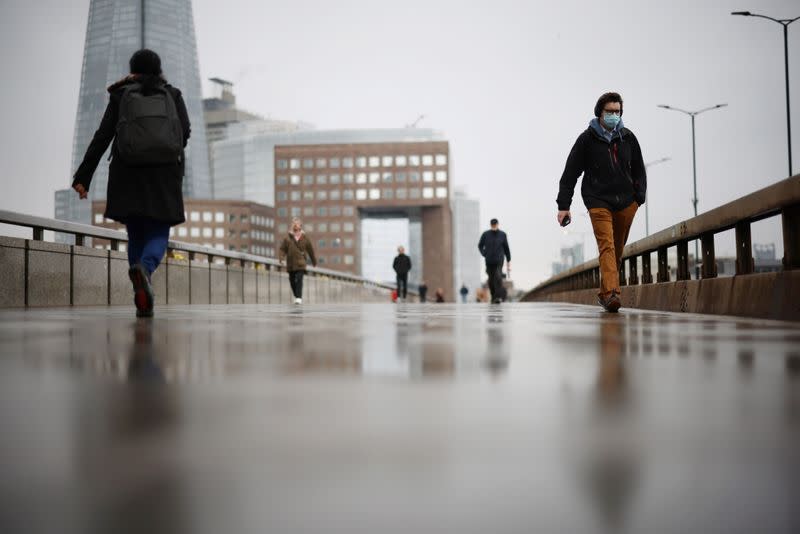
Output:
[{"xmin": 0, "ymin": 0, "xmax": 800, "ymax": 287}]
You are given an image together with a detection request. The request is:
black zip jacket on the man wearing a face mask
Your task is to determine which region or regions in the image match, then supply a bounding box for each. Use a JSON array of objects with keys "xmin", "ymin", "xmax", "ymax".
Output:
[{"xmin": 556, "ymin": 119, "xmax": 647, "ymax": 211}]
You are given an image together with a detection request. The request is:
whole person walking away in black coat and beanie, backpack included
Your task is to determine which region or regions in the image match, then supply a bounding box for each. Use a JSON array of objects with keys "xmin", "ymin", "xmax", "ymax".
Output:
[{"xmin": 72, "ymin": 49, "xmax": 191, "ymax": 317}]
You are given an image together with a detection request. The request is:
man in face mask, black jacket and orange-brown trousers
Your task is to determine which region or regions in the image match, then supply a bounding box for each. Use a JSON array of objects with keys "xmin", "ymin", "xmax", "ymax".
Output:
[{"xmin": 556, "ymin": 93, "xmax": 647, "ymax": 313}]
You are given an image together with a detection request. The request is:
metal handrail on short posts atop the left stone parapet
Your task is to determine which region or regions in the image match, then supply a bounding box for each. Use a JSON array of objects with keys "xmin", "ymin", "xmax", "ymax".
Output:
[{"xmin": 0, "ymin": 210, "xmax": 400, "ymax": 293}]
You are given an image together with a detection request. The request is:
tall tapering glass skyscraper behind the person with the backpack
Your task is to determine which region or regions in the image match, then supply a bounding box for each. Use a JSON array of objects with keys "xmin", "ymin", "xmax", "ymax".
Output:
[{"xmin": 55, "ymin": 0, "xmax": 211, "ymax": 237}]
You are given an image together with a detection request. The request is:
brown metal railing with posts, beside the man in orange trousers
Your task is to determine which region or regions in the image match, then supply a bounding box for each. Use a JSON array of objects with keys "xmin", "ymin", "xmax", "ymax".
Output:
[{"xmin": 523, "ymin": 175, "xmax": 800, "ymax": 300}]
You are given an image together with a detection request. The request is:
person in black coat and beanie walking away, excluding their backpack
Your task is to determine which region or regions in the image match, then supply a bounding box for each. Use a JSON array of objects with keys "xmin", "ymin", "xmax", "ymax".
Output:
[{"xmin": 72, "ymin": 49, "xmax": 191, "ymax": 317}]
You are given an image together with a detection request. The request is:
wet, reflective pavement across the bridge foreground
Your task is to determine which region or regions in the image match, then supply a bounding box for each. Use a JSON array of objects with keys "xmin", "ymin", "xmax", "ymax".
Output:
[{"xmin": 0, "ymin": 304, "xmax": 800, "ymax": 533}]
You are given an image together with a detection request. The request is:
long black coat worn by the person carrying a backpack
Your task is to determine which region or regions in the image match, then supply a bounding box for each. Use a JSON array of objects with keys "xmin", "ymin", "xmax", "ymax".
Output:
[{"xmin": 72, "ymin": 75, "xmax": 191, "ymax": 225}]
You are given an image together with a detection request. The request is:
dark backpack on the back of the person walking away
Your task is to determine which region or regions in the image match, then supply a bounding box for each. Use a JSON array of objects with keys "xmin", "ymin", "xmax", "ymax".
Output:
[{"xmin": 115, "ymin": 83, "xmax": 183, "ymax": 166}]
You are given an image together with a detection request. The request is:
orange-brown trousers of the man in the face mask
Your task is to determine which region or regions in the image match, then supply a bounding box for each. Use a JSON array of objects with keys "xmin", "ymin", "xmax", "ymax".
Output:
[{"xmin": 589, "ymin": 202, "xmax": 639, "ymax": 299}]
